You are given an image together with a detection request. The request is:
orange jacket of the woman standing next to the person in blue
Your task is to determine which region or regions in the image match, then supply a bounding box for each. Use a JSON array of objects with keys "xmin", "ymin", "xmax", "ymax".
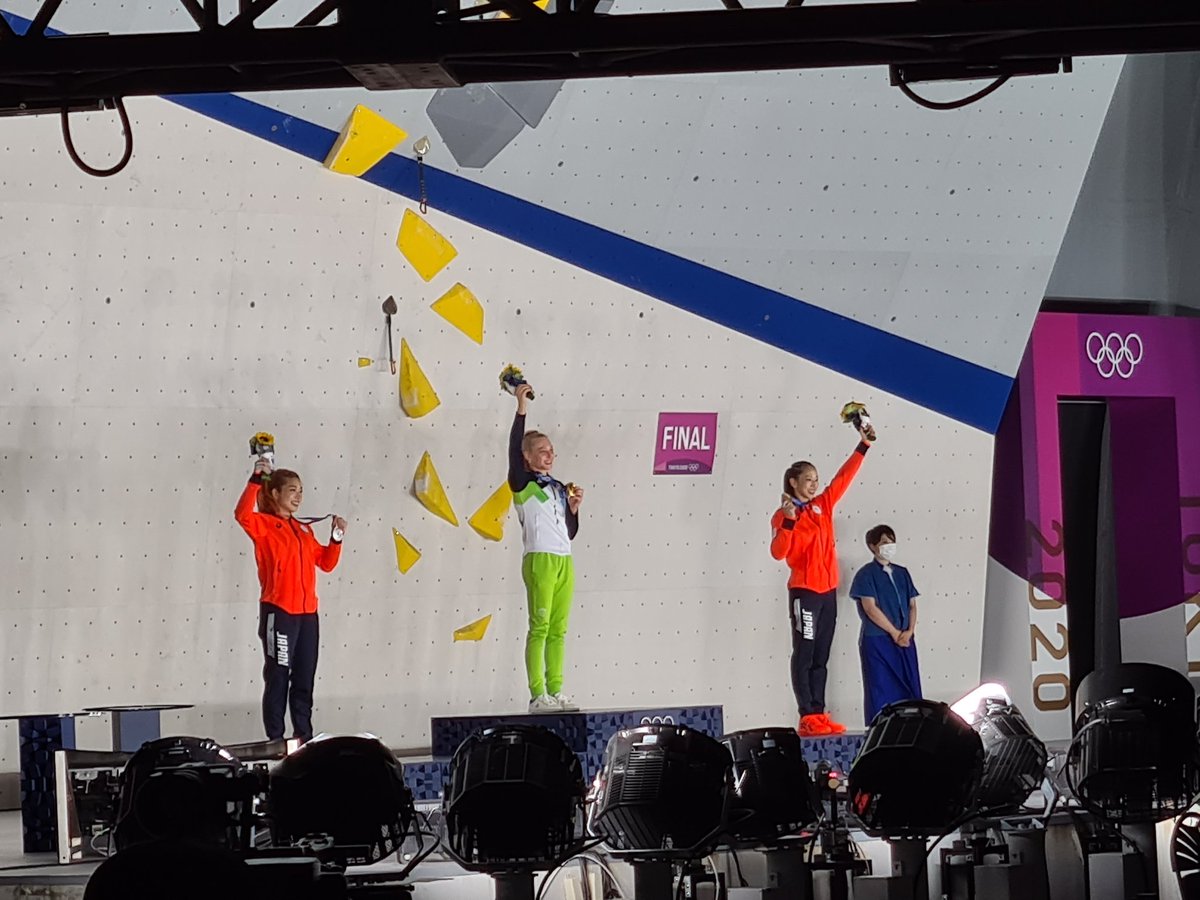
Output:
[{"xmin": 770, "ymin": 443, "xmax": 869, "ymax": 594}]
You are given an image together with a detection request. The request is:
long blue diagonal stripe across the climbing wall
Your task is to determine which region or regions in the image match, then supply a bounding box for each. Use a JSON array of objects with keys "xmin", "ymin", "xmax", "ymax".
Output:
[{"xmin": 5, "ymin": 13, "xmax": 1013, "ymax": 433}]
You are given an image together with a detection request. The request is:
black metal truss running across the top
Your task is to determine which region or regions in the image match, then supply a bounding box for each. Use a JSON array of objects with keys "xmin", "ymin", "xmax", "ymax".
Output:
[{"xmin": 0, "ymin": 0, "xmax": 1200, "ymax": 113}]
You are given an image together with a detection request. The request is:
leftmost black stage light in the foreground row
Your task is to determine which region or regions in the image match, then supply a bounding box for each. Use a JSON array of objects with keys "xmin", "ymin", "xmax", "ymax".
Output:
[{"xmin": 113, "ymin": 737, "xmax": 262, "ymax": 851}]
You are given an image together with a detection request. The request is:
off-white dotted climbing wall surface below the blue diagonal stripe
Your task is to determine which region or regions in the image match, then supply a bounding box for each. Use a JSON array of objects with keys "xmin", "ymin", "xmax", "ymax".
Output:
[{"xmin": 0, "ymin": 100, "xmax": 991, "ymax": 766}]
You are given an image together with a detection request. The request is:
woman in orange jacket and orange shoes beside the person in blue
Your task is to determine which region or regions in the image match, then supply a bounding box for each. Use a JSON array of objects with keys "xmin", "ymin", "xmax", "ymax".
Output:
[{"xmin": 770, "ymin": 431, "xmax": 875, "ymax": 737}]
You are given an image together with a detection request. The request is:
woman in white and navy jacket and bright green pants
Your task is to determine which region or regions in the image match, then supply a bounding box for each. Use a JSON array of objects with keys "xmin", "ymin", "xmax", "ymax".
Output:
[{"xmin": 509, "ymin": 384, "xmax": 583, "ymax": 713}]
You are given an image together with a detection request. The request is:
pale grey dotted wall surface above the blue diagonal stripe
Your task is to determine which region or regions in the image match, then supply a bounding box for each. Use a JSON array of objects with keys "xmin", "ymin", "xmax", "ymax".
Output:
[{"xmin": 2, "ymin": 0, "xmax": 1123, "ymax": 376}]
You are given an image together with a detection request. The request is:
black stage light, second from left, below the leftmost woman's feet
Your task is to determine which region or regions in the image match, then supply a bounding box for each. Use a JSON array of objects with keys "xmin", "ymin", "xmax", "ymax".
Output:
[{"xmin": 268, "ymin": 734, "xmax": 415, "ymax": 865}]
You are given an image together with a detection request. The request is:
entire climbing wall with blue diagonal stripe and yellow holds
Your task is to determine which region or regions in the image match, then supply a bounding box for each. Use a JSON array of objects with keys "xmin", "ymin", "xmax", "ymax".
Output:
[{"xmin": 0, "ymin": 4, "xmax": 1116, "ymax": 768}]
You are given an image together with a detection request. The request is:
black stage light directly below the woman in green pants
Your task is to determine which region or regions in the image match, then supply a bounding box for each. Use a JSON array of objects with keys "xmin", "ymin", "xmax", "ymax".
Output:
[{"xmin": 442, "ymin": 725, "xmax": 584, "ymax": 898}]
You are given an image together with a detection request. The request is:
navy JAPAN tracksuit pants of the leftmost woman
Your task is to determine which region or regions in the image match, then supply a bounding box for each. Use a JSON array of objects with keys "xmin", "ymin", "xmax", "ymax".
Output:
[{"xmin": 258, "ymin": 604, "xmax": 320, "ymax": 742}]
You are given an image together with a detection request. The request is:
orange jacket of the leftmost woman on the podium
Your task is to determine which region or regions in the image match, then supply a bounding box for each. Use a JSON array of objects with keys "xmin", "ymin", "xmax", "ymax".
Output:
[{"xmin": 233, "ymin": 481, "xmax": 342, "ymax": 616}]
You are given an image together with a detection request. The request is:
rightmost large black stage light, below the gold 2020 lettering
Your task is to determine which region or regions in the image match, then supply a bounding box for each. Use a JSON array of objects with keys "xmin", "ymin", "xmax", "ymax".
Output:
[{"xmin": 1067, "ymin": 662, "xmax": 1200, "ymax": 824}]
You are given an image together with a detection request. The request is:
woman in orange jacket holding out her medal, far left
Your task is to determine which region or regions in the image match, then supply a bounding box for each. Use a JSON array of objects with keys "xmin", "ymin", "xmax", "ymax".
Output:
[{"xmin": 234, "ymin": 460, "xmax": 346, "ymax": 740}]
